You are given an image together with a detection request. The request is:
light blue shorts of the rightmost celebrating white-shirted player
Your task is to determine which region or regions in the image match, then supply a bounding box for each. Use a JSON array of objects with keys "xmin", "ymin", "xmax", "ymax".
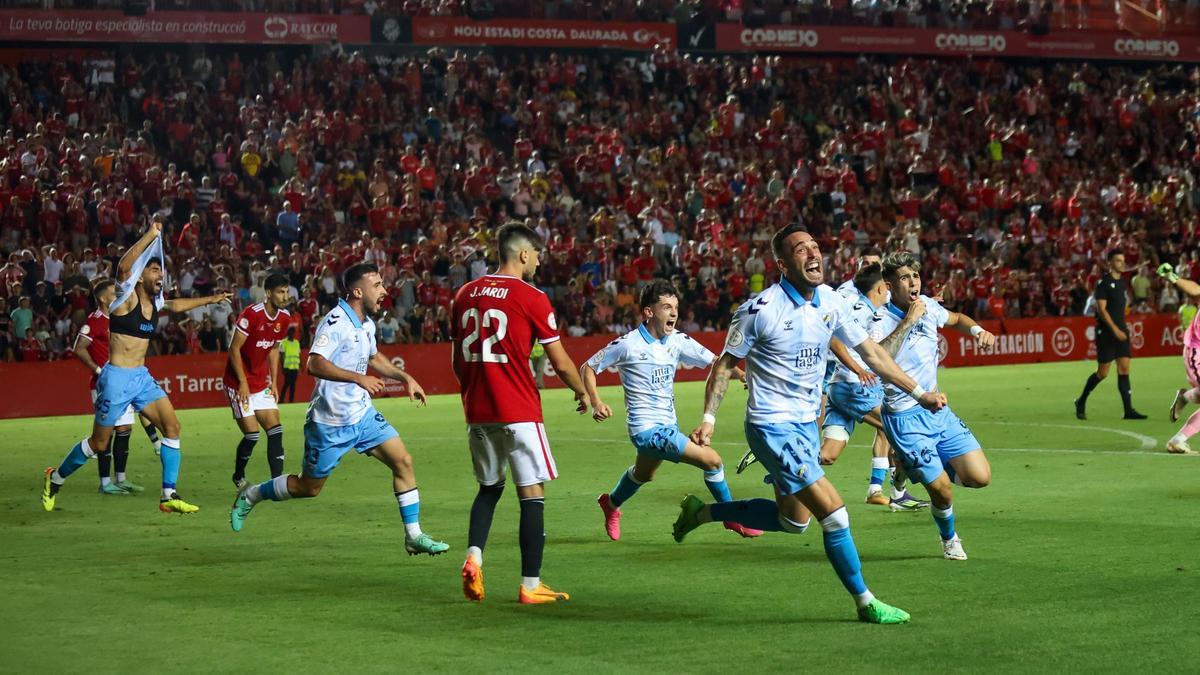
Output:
[{"xmin": 883, "ymin": 406, "xmax": 979, "ymax": 485}]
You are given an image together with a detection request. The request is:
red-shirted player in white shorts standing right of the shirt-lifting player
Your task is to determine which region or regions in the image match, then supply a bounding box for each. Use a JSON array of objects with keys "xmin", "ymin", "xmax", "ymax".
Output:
[{"xmin": 223, "ymin": 273, "xmax": 292, "ymax": 490}]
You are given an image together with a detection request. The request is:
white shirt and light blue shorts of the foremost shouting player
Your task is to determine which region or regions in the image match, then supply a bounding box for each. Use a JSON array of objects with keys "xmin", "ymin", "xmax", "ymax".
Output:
[{"xmin": 725, "ymin": 279, "xmax": 868, "ymax": 495}]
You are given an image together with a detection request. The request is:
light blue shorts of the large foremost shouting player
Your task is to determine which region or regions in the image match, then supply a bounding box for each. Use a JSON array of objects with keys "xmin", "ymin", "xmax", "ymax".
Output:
[{"xmin": 745, "ymin": 422, "xmax": 824, "ymax": 495}]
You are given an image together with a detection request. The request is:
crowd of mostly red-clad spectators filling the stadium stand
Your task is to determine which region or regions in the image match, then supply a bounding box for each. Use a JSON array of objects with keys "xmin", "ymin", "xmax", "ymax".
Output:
[{"xmin": 0, "ymin": 43, "xmax": 1200, "ymax": 359}]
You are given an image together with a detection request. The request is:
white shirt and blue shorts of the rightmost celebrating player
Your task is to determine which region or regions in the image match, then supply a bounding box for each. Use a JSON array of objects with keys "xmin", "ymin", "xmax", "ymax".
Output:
[{"xmin": 871, "ymin": 295, "xmax": 979, "ymax": 484}]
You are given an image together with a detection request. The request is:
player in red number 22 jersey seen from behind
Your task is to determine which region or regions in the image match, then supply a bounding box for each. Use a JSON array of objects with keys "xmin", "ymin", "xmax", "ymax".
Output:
[{"xmin": 450, "ymin": 223, "xmax": 592, "ymax": 604}]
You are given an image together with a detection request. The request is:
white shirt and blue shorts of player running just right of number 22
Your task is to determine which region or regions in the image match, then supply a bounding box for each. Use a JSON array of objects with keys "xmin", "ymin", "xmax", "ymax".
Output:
[{"xmin": 587, "ymin": 325, "xmax": 716, "ymax": 462}]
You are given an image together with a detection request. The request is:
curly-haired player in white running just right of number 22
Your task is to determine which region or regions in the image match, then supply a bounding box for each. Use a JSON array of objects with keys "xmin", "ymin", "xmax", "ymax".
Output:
[{"xmin": 580, "ymin": 280, "xmax": 762, "ymax": 542}]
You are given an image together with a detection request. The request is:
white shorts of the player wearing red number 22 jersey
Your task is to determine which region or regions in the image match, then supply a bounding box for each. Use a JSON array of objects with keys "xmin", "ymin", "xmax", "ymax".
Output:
[{"xmin": 467, "ymin": 422, "xmax": 558, "ymax": 488}]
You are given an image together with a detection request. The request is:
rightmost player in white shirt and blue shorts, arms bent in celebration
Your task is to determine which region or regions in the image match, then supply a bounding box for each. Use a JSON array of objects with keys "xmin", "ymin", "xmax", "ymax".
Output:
[{"xmin": 871, "ymin": 252, "xmax": 996, "ymax": 560}]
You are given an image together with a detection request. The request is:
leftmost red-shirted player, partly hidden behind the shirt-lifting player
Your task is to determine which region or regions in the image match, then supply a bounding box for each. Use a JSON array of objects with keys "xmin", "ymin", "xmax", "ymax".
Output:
[{"xmin": 74, "ymin": 277, "xmax": 162, "ymax": 495}]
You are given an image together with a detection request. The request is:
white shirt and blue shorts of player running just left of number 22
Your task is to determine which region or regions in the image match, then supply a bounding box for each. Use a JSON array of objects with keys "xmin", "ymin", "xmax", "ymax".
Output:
[{"xmin": 304, "ymin": 300, "xmax": 398, "ymax": 478}]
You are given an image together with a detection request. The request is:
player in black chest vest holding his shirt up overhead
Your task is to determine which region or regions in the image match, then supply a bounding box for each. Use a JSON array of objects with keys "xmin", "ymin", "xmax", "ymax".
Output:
[{"xmin": 42, "ymin": 217, "xmax": 230, "ymax": 513}]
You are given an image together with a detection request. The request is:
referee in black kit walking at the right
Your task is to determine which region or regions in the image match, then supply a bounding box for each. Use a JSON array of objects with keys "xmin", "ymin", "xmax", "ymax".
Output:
[{"xmin": 1075, "ymin": 250, "xmax": 1146, "ymax": 419}]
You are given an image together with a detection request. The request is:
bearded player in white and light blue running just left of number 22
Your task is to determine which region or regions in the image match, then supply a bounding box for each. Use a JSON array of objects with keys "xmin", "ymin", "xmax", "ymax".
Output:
[{"xmin": 229, "ymin": 263, "xmax": 450, "ymax": 555}]
